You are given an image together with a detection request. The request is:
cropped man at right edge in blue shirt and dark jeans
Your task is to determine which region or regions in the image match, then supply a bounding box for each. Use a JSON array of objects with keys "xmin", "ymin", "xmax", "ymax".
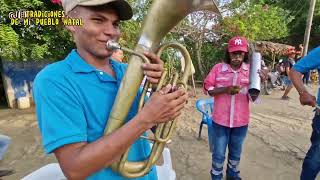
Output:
[{"xmin": 290, "ymin": 47, "xmax": 320, "ymax": 180}]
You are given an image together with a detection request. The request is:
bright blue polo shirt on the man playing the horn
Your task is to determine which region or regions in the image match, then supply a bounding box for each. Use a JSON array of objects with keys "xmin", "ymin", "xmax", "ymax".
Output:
[{"xmin": 33, "ymin": 50, "xmax": 157, "ymax": 180}]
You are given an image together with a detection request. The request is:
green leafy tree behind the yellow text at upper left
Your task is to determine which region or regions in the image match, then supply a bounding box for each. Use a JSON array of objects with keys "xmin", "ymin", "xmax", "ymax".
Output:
[{"xmin": 0, "ymin": 0, "xmax": 74, "ymax": 61}]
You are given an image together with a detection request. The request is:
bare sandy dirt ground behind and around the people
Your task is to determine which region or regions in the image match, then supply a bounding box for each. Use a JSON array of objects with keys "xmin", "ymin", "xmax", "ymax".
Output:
[{"xmin": 0, "ymin": 86, "xmax": 320, "ymax": 180}]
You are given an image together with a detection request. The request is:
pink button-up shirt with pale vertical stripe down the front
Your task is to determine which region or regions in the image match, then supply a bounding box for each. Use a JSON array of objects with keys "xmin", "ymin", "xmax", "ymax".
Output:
[{"xmin": 204, "ymin": 63, "xmax": 250, "ymax": 128}]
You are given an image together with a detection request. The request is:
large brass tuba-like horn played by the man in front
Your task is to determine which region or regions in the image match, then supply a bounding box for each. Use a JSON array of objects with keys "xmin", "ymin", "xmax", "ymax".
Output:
[{"xmin": 105, "ymin": 0, "xmax": 220, "ymax": 178}]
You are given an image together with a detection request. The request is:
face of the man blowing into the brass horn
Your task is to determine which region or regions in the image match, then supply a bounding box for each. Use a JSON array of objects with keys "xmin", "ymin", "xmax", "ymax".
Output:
[{"xmin": 69, "ymin": 6, "xmax": 120, "ymax": 59}]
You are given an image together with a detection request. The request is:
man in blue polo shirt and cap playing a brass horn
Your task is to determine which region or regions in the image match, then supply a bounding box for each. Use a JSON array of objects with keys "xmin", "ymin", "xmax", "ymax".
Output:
[{"xmin": 33, "ymin": 0, "xmax": 187, "ymax": 180}]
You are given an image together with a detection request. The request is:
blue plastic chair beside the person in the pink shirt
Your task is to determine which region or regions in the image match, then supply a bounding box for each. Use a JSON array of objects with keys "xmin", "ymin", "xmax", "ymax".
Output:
[{"xmin": 196, "ymin": 98, "xmax": 214, "ymax": 152}]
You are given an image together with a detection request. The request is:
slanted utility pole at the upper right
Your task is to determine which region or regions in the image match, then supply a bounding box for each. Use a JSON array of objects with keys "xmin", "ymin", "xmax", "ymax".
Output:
[{"xmin": 303, "ymin": 0, "xmax": 316, "ymax": 56}]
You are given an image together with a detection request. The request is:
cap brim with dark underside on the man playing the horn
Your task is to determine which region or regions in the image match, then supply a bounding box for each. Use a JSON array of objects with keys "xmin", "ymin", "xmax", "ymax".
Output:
[{"xmin": 78, "ymin": 0, "xmax": 133, "ymax": 20}]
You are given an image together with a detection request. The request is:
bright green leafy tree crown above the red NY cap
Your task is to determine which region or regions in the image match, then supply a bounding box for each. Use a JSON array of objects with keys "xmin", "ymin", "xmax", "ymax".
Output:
[{"xmin": 218, "ymin": 3, "xmax": 293, "ymax": 40}]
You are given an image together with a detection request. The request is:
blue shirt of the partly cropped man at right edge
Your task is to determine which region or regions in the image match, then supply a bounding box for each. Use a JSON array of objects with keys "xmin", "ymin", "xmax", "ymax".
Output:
[{"xmin": 292, "ymin": 47, "xmax": 320, "ymax": 105}]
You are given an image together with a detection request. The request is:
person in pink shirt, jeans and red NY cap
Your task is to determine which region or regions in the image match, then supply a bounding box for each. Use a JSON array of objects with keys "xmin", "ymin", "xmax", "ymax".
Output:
[{"xmin": 204, "ymin": 36, "xmax": 262, "ymax": 180}]
